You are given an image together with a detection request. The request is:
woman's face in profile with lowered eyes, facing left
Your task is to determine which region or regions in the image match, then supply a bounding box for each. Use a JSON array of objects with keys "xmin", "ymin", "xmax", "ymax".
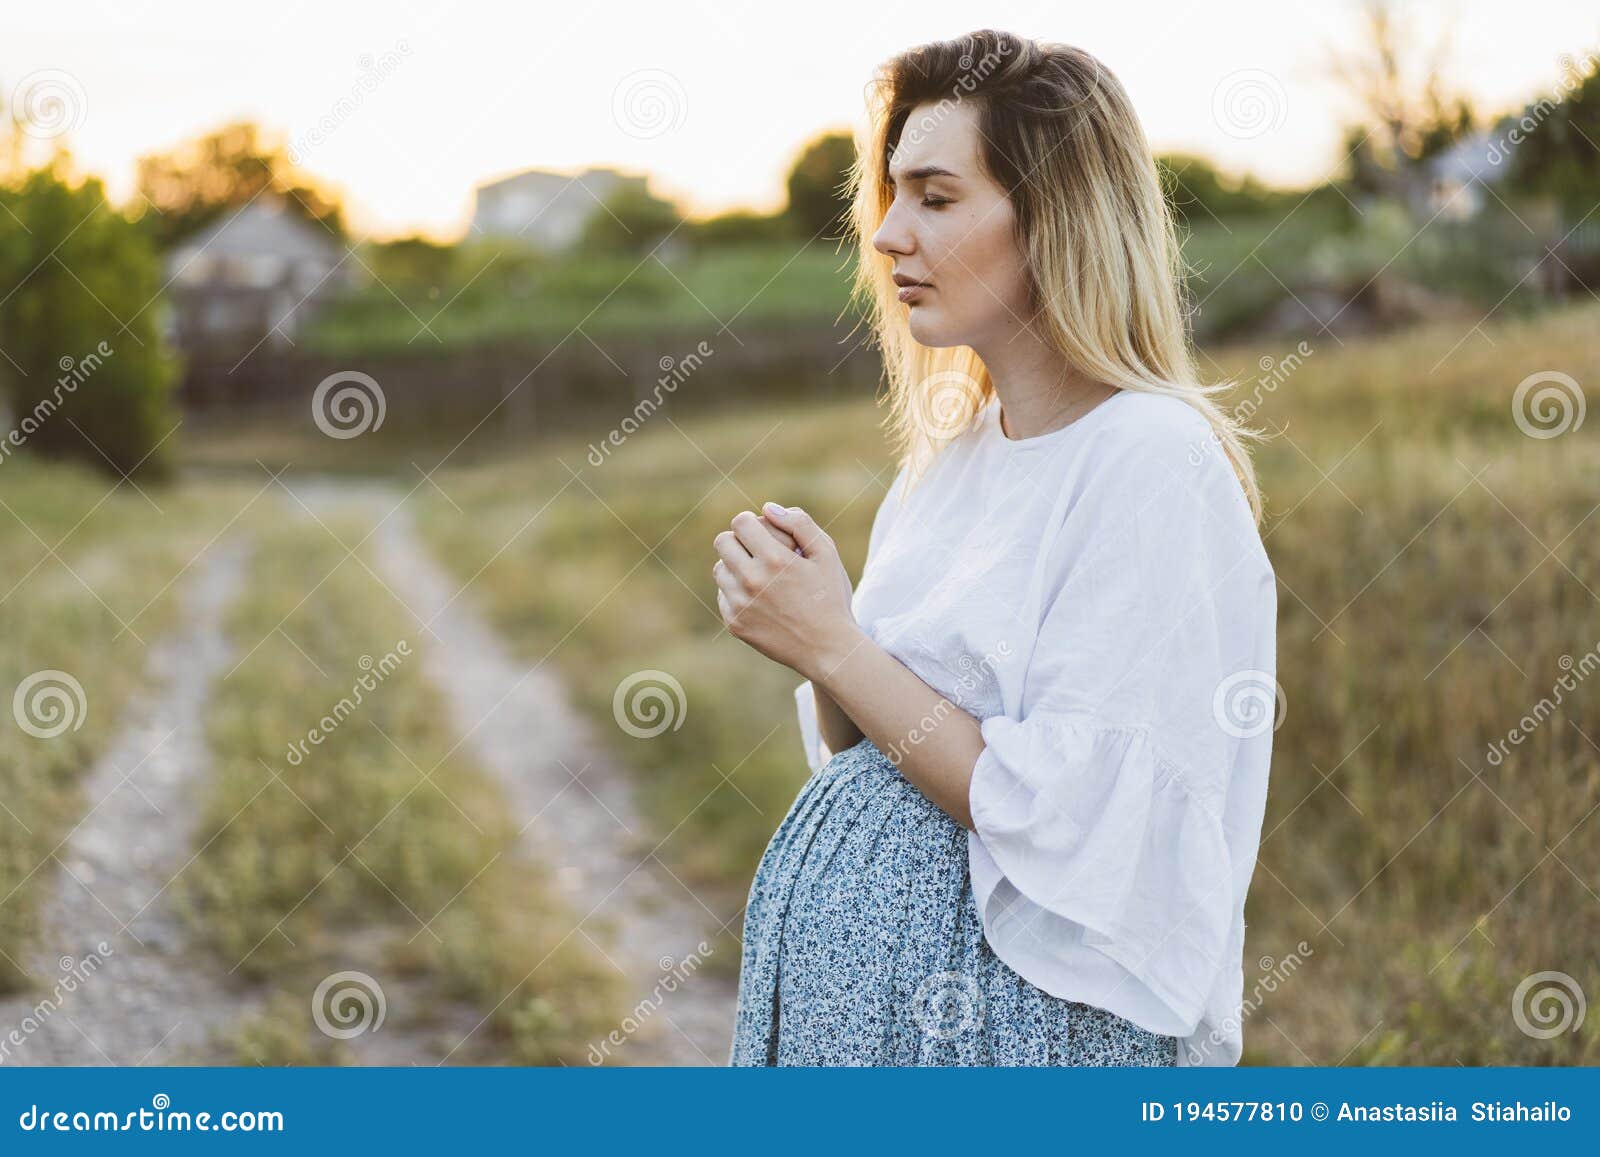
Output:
[{"xmin": 872, "ymin": 102, "xmax": 1027, "ymax": 355}]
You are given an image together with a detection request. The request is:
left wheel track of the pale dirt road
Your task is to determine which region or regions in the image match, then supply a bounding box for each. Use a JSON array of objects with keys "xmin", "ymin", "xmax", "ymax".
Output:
[{"xmin": 0, "ymin": 542, "xmax": 250, "ymax": 1064}]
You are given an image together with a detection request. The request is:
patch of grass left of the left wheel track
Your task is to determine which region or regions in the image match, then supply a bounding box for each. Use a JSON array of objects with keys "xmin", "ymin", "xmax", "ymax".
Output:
[{"xmin": 0, "ymin": 458, "xmax": 259, "ymax": 992}]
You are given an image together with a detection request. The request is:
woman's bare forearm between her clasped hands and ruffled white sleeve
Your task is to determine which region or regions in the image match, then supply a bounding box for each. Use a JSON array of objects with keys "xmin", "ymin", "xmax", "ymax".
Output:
[{"xmin": 802, "ymin": 626, "xmax": 984, "ymax": 829}]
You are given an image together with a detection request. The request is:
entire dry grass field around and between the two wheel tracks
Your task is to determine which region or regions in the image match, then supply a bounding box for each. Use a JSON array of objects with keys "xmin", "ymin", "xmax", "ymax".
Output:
[{"xmin": 0, "ymin": 302, "xmax": 1600, "ymax": 1064}]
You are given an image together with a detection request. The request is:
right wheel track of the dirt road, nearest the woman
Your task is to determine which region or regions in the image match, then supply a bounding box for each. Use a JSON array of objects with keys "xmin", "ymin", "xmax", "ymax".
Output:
[{"xmin": 294, "ymin": 478, "xmax": 734, "ymax": 1066}]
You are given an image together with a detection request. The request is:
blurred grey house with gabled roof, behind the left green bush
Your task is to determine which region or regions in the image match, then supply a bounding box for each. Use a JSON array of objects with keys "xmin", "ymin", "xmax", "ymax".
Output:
[{"xmin": 166, "ymin": 194, "xmax": 352, "ymax": 349}]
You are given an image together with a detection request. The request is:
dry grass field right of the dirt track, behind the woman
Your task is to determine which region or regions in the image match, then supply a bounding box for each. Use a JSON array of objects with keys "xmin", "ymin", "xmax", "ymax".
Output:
[{"xmin": 409, "ymin": 304, "xmax": 1600, "ymax": 1064}]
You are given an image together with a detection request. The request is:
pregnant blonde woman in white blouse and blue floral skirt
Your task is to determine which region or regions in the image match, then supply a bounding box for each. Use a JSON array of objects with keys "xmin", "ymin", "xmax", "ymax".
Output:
[{"xmin": 712, "ymin": 32, "xmax": 1278, "ymax": 1066}]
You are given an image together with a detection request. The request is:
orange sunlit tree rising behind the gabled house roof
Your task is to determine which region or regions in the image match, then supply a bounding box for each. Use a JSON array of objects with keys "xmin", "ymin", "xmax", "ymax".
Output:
[{"xmin": 138, "ymin": 120, "xmax": 347, "ymax": 250}]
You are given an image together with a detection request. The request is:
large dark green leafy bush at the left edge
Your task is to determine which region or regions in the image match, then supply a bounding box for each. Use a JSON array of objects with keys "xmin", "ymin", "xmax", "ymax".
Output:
[{"xmin": 0, "ymin": 155, "xmax": 178, "ymax": 477}]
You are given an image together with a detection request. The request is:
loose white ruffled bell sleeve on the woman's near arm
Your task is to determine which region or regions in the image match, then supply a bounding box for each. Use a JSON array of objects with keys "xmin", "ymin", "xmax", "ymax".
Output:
[{"xmin": 968, "ymin": 425, "xmax": 1277, "ymax": 1064}]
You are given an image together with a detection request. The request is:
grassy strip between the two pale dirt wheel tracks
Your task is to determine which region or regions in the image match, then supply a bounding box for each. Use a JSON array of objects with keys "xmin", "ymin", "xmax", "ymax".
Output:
[{"xmin": 179, "ymin": 514, "xmax": 619, "ymax": 1064}]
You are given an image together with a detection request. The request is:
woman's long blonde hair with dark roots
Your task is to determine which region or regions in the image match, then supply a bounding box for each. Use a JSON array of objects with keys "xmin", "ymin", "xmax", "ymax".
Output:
[{"xmin": 848, "ymin": 29, "xmax": 1262, "ymax": 523}]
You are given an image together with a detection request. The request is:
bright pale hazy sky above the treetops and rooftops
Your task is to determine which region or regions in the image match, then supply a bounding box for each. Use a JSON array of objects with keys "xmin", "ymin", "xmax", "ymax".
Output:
[{"xmin": 0, "ymin": 0, "xmax": 1600, "ymax": 235}]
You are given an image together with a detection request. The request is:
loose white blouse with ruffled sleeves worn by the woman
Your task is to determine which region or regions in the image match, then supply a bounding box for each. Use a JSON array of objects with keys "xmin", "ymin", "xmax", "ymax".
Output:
[{"xmin": 795, "ymin": 390, "xmax": 1278, "ymax": 1066}]
